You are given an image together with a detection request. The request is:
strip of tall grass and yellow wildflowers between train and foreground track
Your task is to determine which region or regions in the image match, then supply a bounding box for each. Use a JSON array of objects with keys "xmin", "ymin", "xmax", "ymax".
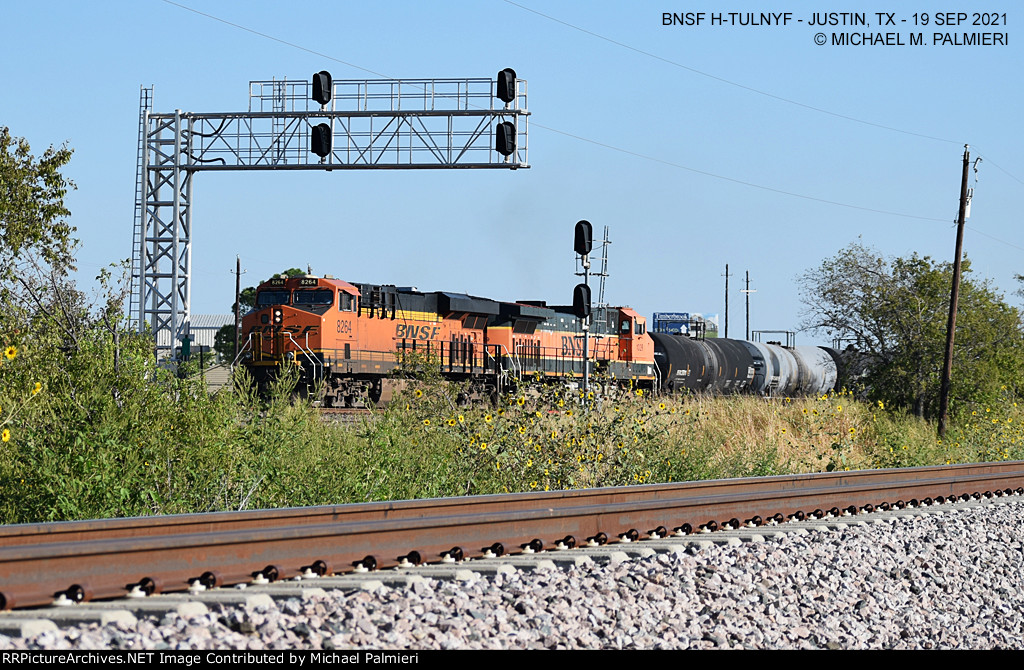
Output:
[{"xmin": 0, "ymin": 339, "xmax": 1024, "ymax": 524}]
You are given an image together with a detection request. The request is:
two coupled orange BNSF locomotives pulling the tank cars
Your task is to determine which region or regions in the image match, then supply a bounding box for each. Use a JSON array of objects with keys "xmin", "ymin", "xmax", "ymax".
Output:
[{"xmin": 241, "ymin": 275, "xmax": 657, "ymax": 407}]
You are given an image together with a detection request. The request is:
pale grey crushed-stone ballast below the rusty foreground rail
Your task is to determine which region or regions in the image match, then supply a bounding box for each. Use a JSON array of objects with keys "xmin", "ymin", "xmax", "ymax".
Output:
[{"xmin": 0, "ymin": 497, "xmax": 1024, "ymax": 651}]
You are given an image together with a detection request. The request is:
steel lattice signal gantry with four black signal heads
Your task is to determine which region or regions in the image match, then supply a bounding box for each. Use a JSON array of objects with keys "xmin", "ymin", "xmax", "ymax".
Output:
[{"xmin": 129, "ymin": 69, "xmax": 529, "ymax": 358}]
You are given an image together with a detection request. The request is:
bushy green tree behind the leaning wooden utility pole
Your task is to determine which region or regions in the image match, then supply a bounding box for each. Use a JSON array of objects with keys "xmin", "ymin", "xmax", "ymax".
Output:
[{"xmin": 798, "ymin": 242, "xmax": 1024, "ymax": 417}]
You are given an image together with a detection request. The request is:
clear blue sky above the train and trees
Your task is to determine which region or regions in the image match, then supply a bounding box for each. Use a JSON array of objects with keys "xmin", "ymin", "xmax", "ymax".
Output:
[{"xmin": 0, "ymin": 0, "xmax": 1024, "ymax": 343}]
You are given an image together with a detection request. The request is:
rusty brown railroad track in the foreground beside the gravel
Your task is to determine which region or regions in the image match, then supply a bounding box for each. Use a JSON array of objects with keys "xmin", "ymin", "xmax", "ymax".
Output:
[{"xmin": 0, "ymin": 462, "xmax": 1024, "ymax": 609}]
